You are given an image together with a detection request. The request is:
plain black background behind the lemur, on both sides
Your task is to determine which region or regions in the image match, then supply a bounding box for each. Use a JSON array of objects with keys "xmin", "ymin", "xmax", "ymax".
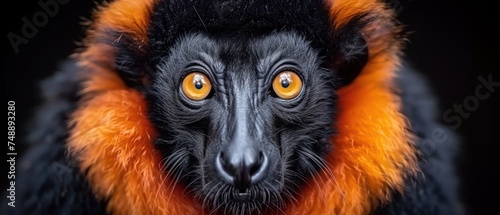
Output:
[{"xmin": 1, "ymin": 0, "xmax": 500, "ymax": 214}]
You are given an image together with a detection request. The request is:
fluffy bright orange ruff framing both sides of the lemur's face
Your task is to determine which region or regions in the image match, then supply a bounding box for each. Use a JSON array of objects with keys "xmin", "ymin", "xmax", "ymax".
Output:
[{"xmin": 68, "ymin": 0, "xmax": 418, "ymax": 215}]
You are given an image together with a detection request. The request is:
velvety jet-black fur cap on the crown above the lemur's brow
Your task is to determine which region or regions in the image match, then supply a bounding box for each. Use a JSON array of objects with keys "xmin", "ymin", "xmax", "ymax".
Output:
[{"xmin": 148, "ymin": 0, "xmax": 331, "ymax": 62}]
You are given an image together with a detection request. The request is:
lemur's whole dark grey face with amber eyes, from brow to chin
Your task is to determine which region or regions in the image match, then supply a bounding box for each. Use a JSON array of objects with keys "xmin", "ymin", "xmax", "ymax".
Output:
[{"xmin": 148, "ymin": 33, "xmax": 336, "ymax": 214}]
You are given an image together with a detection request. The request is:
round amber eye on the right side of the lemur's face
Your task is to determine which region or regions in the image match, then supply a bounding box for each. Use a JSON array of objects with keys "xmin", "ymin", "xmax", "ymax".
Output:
[{"xmin": 273, "ymin": 71, "xmax": 302, "ymax": 100}]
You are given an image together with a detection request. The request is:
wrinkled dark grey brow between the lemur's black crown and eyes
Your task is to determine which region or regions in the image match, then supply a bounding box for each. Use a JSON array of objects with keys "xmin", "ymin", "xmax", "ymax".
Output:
[{"xmin": 166, "ymin": 32, "xmax": 320, "ymax": 72}]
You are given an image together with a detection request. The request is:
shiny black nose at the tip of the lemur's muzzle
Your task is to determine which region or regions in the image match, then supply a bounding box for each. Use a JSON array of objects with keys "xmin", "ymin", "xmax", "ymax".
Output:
[{"xmin": 215, "ymin": 148, "xmax": 269, "ymax": 193}]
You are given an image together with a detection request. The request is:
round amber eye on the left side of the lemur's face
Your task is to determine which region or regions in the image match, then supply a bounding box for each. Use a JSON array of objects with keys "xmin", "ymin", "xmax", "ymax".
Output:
[{"xmin": 182, "ymin": 72, "xmax": 212, "ymax": 101}]
